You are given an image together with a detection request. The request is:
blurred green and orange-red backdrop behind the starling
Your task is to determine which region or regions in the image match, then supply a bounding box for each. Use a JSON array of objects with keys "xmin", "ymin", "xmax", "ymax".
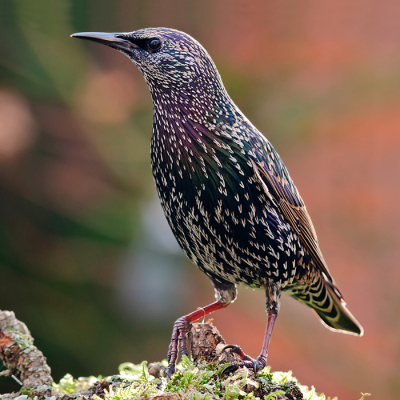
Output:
[{"xmin": 0, "ymin": 0, "xmax": 400, "ymax": 399}]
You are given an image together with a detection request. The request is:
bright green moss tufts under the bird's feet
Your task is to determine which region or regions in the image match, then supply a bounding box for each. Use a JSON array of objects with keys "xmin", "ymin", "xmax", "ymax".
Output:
[{"xmin": 54, "ymin": 357, "xmax": 372, "ymax": 400}]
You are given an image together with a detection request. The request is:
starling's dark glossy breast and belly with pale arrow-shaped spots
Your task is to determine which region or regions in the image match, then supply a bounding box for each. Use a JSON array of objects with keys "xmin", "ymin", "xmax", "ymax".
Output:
[{"xmin": 151, "ymin": 115, "xmax": 299, "ymax": 287}]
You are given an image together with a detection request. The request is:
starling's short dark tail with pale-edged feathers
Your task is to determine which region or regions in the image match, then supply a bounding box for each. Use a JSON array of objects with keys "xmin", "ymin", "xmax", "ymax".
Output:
[{"xmin": 292, "ymin": 276, "xmax": 364, "ymax": 336}]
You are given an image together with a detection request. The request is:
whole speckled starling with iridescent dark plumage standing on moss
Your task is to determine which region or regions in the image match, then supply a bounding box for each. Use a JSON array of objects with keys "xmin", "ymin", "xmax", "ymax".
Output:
[{"xmin": 71, "ymin": 28, "xmax": 364, "ymax": 377}]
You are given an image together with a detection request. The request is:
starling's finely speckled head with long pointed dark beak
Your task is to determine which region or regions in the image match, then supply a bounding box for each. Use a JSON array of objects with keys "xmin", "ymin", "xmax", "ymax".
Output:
[{"xmin": 71, "ymin": 28, "xmax": 224, "ymax": 102}]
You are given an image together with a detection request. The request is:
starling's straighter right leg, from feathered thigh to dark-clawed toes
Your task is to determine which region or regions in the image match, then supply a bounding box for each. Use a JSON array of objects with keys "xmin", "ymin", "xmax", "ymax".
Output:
[{"xmin": 221, "ymin": 280, "xmax": 281, "ymax": 375}]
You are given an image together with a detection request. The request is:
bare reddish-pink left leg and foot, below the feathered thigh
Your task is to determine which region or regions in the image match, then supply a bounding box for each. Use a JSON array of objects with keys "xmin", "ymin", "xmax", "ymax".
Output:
[{"xmin": 167, "ymin": 300, "xmax": 228, "ymax": 378}]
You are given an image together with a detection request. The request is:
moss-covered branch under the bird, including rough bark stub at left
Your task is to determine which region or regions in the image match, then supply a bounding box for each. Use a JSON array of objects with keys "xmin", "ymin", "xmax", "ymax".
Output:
[{"xmin": 0, "ymin": 311, "xmax": 364, "ymax": 400}]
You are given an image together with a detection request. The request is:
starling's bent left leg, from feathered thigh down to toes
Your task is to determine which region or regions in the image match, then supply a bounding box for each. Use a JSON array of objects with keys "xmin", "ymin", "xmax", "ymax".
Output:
[{"xmin": 167, "ymin": 279, "xmax": 236, "ymax": 378}]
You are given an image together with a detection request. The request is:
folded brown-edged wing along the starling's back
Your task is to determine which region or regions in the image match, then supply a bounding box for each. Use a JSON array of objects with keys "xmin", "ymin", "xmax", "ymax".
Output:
[{"xmin": 250, "ymin": 146, "xmax": 333, "ymax": 283}]
